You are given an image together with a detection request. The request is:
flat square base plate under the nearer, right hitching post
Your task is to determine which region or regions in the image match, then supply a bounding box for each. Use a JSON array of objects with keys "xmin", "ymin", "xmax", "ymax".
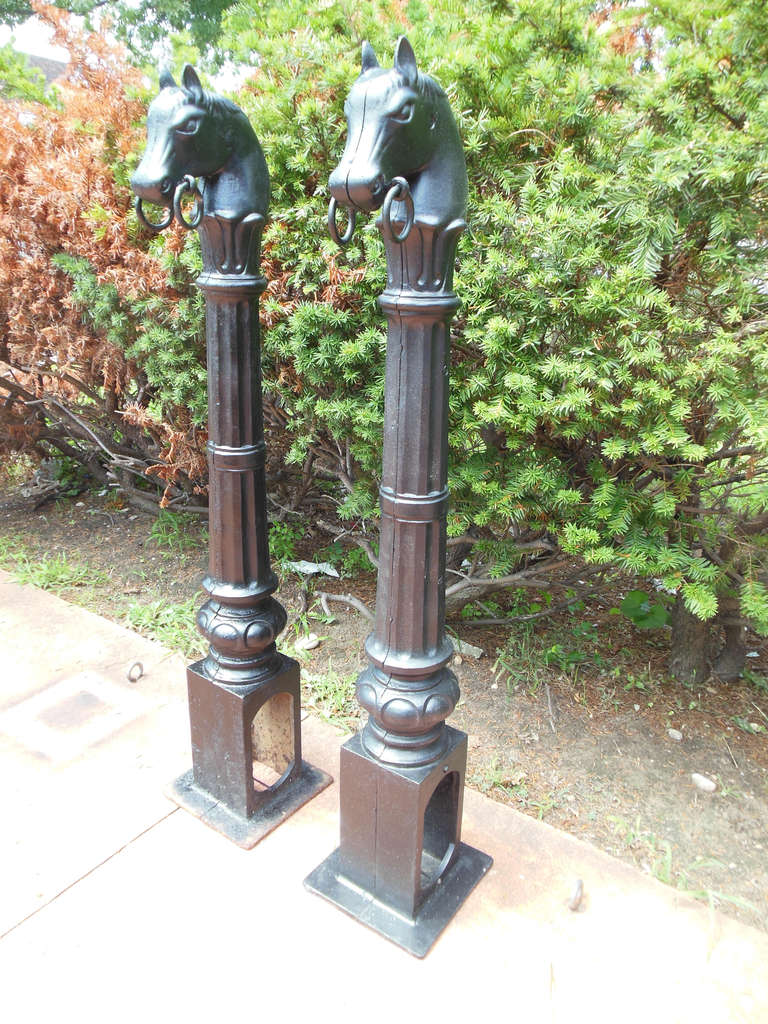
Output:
[{"xmin": 304, "ymin": 843, "xmax": 494, "ymax": 957}]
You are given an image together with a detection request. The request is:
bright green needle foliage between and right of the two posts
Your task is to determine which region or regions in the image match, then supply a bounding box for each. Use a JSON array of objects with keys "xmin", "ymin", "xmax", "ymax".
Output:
[{"xmin": 211, "ymin": 0, "xmax": 768, "ymax": 667}]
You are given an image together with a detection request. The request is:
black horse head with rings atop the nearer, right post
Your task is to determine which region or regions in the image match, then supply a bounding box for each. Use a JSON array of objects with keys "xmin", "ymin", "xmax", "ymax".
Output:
[{"xmin": 329, "ymin": 36, "xmax": 467, "ymax": 264}]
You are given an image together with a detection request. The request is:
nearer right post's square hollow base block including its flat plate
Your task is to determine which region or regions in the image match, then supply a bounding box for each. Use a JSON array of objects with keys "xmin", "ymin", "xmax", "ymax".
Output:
[{"xmin": 305, "ymin": 726, "xmax": 493, "ymax": 956}]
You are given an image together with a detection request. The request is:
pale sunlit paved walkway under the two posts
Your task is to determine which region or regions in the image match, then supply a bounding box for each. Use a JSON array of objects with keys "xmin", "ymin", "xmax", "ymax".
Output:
[{"xmin": 0, "ymin": 573, "xmax": 768, "ymax": 1024}]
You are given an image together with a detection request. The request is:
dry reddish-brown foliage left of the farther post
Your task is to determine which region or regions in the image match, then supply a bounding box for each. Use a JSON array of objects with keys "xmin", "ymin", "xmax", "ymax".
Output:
[{"xmin": 0, "ymin": 2, "xmax": 205, "ymax": 501}]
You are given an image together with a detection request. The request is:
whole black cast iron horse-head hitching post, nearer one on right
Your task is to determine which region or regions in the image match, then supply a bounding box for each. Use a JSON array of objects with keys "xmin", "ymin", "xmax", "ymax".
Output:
[{"xmin": 306, "ymin": 38, "xmax": 492, "ymax": 956}]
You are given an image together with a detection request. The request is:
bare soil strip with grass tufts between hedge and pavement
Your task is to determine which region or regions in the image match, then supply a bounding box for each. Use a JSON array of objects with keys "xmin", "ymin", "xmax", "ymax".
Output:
[{"xmin": 0, "ymin": 488, "xmax": 768, "ymax": 930}]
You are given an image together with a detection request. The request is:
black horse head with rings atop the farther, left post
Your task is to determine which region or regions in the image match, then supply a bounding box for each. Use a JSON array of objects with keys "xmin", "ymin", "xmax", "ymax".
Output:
[{"xmin": 131, "ymin": 65, "xmax": 269, "ymax": 272}]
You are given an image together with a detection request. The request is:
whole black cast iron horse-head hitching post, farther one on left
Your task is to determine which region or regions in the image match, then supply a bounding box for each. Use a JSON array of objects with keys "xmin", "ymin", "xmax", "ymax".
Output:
[{"xmin": 131, "ymin": 65, "xmax": 331, "ymax": 848}]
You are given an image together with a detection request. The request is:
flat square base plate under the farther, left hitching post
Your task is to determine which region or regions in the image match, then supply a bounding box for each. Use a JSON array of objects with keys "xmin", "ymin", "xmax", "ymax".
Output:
[{"xmin": 166, "ymin": 761, "xmax": 333, "ymax": 850}]
